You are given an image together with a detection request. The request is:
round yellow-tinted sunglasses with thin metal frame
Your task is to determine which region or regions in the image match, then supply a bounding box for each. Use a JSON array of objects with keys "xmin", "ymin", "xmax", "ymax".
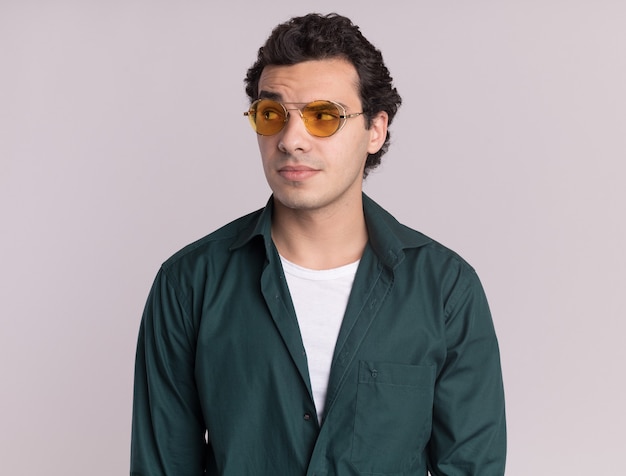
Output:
[{"xmin": 243, "ymin": 99, "xmax": 363, "ymax": 137}]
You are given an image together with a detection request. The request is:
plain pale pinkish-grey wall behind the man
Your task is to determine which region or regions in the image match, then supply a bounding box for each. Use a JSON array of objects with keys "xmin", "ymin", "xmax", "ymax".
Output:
[{"xmin": 0, "ymin": 0, "xmax": 626, "ymax": 476}]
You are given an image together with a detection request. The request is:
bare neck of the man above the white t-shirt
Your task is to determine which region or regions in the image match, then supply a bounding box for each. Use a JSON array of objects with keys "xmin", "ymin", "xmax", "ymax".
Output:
[{"xmin": 272, "ymin": 196, "xmax": 368, "ymax": 269}]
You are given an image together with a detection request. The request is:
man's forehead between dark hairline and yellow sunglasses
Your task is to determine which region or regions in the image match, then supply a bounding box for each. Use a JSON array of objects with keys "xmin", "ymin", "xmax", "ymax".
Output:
[{"xmin": 259, "ymin": 58, "xmax": 359, "ymax": 102}]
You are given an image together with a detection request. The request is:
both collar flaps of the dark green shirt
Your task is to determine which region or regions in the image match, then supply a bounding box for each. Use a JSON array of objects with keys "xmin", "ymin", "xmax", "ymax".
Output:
[{"xmin": 231, "ymin": 194, "xmax": 432, "ymax": 268}]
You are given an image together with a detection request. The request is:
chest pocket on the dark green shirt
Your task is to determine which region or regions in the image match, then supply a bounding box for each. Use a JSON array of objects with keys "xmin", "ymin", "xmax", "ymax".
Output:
[{"xmin": 351, "ymin": 361, "xmax": 435, "ymax": 475}]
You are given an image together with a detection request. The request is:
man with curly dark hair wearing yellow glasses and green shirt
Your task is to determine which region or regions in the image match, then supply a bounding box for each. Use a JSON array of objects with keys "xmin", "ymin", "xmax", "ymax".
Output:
[{"xmin": 131, "ymin": 11, "xmax": 506, "ymax": 476}]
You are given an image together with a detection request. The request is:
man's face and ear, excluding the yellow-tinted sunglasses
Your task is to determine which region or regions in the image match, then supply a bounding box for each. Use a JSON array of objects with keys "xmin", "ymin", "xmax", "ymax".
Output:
[{"xmin": 258, "ymin": 59, "xmax": 387, "ymax": 216}]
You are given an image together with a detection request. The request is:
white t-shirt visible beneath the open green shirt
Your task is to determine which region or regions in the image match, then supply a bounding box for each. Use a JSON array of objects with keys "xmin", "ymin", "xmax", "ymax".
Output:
[{"xmin": 281, "ymin": 256, "xmax": 359, "ymax": 420}]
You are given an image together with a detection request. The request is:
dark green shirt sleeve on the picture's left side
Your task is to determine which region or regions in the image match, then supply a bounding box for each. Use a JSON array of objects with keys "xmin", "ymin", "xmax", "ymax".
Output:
[{"xmin": 130, "ymin": 269, "xmax": 207, "ymax": 476}]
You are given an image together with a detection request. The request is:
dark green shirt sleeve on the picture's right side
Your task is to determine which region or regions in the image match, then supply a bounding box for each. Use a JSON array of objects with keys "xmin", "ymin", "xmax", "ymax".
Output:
[{"xmin": 428, "ymin": 268, "xmax": 506, "ymax": 476}]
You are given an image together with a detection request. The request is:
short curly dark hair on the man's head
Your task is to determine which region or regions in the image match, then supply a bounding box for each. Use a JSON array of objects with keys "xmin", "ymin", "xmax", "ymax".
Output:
[{"xmin": 245, "ymin": 13, "xmax": 402, "ymax": 176}]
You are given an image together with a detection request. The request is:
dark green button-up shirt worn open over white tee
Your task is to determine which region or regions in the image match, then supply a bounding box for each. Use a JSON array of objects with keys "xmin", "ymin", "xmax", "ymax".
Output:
[{"xmin": 130, "ymin": 195, "xmax": 506, "ymax": 476}]
